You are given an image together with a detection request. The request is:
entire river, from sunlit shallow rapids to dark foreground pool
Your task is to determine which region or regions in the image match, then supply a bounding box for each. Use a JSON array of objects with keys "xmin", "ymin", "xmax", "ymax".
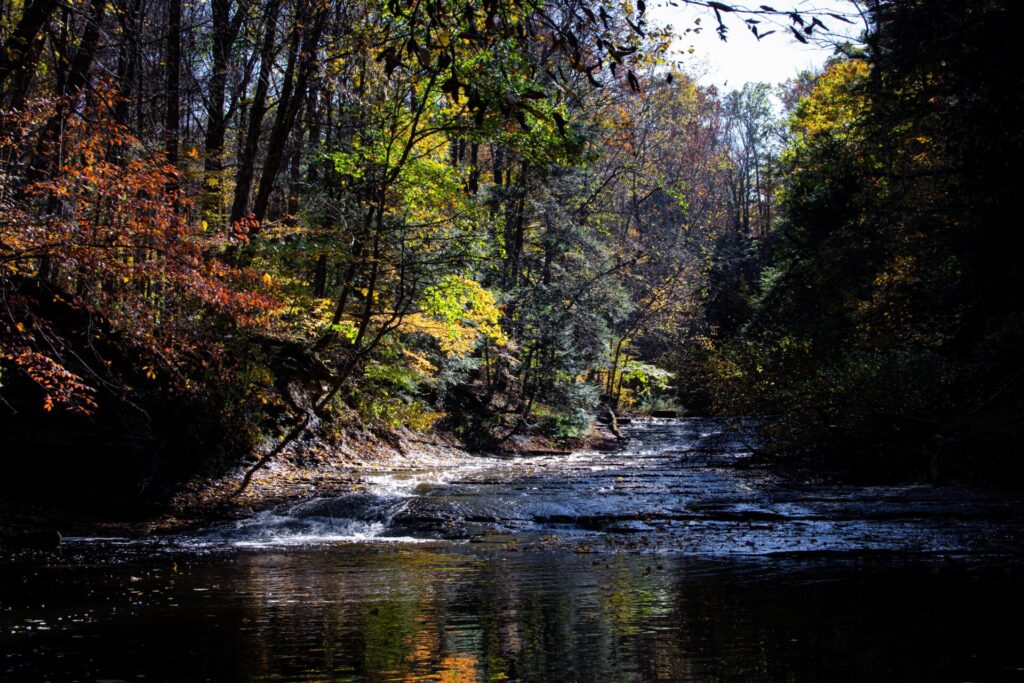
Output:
[{"xmin": 0, "ymin": 420, "xmax": 1024, "ymax": 682}]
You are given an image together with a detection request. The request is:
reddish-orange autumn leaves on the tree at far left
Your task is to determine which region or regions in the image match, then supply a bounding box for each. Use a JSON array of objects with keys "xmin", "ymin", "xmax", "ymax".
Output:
[{"xmin": 0, "ymin": 86, "xmax": 270, "ymax": 412}]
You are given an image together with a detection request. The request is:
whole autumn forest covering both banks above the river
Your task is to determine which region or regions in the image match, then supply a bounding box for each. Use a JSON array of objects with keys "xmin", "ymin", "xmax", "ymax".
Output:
[{"xmin": 0, "ymin": 0, "xmax": 1024, "ymax": 503}]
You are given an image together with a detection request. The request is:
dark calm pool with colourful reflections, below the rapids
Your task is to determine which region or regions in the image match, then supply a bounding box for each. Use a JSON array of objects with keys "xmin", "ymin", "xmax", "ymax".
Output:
[{"xmin": 0, "ymin": 545, "xmax": 1024, "ymax": 682}]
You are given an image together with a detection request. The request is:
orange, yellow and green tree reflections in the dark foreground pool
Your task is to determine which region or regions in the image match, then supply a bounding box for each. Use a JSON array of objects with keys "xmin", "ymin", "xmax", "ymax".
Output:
[{"xmin": 234, "ymin": 550, "xmax": 692, "ymax": 681}]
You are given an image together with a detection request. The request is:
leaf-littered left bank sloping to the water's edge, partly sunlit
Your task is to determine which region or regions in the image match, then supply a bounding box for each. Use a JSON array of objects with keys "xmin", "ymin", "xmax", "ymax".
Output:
[{"xmin": 0, "ymin": 423, "xmax": 620, "ymax": 548}]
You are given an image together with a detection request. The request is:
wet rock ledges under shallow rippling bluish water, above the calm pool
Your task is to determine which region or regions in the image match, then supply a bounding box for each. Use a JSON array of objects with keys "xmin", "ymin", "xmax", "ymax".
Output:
[{"xmin": 153, "ymin": 418, "xmax": 1024, "ymax": 556}]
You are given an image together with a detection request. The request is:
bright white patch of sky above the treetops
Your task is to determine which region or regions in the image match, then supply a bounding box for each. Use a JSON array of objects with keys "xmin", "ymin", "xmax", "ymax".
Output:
[{"xmin": 648, "ymin": 0, "xmax": 862, "ymax": 90}]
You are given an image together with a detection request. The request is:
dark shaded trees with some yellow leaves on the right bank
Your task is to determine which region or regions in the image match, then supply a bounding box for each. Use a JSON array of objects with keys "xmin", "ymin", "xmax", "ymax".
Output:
[{"xmin": 680, "ymin": 0, "xmax": 1024, "ymax": 476}]
